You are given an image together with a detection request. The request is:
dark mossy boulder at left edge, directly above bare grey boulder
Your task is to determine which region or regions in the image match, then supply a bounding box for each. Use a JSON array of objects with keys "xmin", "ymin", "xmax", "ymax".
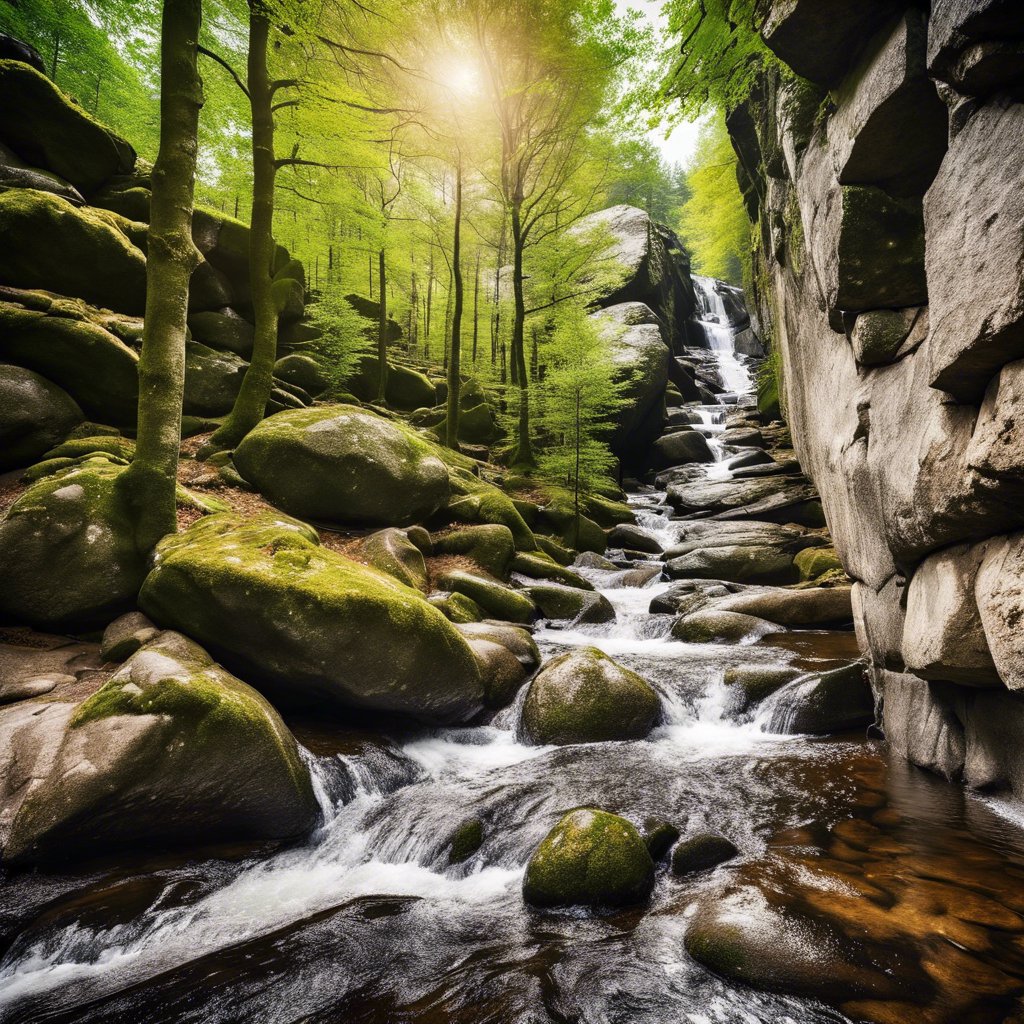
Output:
[{"xmin": 0, "ymin": 296, "xmax": 138, "ymax": 426}]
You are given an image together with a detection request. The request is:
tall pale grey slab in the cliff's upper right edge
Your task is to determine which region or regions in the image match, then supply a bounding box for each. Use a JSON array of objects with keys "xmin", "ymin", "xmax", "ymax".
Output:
[{"xmin": 925, "ymin": 100, "xmax": 1024, "ymax": 401}]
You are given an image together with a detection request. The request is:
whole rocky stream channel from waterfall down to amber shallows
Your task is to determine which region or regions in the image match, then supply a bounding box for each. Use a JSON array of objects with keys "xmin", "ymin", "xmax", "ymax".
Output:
[{"xmin": 6, "ymin": 278, "xmax": 1024, "ymax": 1024}]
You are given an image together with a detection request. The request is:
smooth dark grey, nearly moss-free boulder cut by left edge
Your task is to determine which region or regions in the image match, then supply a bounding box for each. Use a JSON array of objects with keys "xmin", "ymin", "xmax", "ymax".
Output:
[{"xmin": 0, "ymin": 366, "xmax": 85, "ymax": 473}]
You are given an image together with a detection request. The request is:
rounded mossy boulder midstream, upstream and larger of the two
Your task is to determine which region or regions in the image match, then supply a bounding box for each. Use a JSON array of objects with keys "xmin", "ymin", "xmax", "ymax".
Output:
[{"xmin": 522, "ymin": 647, "xmax": 662, "ymax": 744}]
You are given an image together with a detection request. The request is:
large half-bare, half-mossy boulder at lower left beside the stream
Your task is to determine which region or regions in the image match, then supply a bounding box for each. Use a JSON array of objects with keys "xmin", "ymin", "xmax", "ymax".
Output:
[{"xmin": 0, "ymin": 633, "xmax": 318, "ymax": 863}]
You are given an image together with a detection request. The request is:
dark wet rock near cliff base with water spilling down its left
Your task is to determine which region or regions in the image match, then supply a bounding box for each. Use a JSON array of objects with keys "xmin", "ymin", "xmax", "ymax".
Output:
[{"xmin": 768, "ymin": 662, "xmax": 874, "ymax": 736}]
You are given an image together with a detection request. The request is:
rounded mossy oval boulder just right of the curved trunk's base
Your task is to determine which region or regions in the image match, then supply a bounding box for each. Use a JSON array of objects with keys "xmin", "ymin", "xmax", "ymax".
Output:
[{"xmin": 234, "ymin": 406, "xmax": 449, "ymax": 526}]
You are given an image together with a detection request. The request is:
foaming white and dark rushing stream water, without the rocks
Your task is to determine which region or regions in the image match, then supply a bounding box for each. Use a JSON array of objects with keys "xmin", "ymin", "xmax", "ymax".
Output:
[{"xmin": 6, "ymin": 290, "xmax": 1024, "ymax": 1024}]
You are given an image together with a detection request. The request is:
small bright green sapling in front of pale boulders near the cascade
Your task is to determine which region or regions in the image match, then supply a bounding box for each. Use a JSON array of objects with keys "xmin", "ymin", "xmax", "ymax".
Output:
[{"xmin": 539, "ymin": 303, "xmax": 629, "ymax": 522}]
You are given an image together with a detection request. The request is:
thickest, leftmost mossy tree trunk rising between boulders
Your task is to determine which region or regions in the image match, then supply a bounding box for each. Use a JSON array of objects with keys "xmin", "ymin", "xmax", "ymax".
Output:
[{"xmin": 121, "ymin": 0, "xmax": 203, "ymax": 552}]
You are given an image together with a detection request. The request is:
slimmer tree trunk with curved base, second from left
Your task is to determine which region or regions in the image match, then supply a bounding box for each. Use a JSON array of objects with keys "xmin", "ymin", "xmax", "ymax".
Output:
[{"xmin": 205, "ymin": 0, "xmax": 280, "ymax": 452}]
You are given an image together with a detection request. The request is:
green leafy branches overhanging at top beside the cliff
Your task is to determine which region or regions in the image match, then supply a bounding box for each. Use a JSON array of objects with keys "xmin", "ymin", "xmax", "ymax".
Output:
[{"xmin": 658, "ymin": 0, "xmax": 780, "ymax": 122}]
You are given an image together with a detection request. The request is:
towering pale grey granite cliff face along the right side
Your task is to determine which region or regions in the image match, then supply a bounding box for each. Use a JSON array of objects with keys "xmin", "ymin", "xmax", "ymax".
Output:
[{"xmin": 729, "ymin": 9, "xmax": 1024, "ymax": 796}]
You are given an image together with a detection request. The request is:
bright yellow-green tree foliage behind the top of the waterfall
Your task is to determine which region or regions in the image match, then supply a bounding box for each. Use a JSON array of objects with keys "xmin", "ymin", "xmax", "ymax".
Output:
[{"xmin": 679, "ymin": 115, "xmax": 751, "ymax": 286}]
